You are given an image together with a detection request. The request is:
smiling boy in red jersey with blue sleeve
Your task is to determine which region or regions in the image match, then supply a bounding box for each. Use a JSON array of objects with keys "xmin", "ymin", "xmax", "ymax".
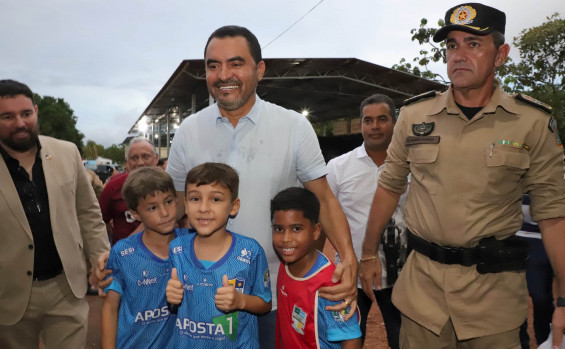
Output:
[{"xmin": 271, "ymin": 188, "xmax": 361, "ymax": 349}]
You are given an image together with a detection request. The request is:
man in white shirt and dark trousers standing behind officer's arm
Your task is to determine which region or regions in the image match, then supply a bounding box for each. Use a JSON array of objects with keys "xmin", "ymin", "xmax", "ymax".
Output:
[{"xmin": 327, "ymin": 94, "xmax": 406, "ymax": 349}]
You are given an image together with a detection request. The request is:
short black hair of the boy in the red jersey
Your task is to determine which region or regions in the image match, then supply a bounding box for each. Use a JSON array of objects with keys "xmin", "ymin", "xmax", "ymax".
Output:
[{"xmin": 271, "ymin": 187, "xmax": 320, "ymax": 225}]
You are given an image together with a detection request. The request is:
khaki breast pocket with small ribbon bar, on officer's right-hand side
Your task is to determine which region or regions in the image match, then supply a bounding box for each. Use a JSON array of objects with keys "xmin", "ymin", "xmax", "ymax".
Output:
[{"xmin": 485, "ymin": 144, "xmax": 530, "ymax": 200}]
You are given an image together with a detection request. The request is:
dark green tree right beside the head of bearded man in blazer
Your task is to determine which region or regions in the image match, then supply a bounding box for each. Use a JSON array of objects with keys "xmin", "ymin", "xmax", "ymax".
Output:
[{"xmin": 34, "ymin": 94, "xmax": 84, "ymax": 153}]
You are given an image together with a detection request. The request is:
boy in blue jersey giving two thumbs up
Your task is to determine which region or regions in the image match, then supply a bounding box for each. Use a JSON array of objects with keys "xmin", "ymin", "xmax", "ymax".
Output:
[{"xmin": 167, "ymin": 163, "xmax": 271, "ymax": 349}]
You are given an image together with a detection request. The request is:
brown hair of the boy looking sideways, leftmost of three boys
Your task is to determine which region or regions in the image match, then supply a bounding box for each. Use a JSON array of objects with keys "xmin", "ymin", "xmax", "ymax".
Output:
[{"xmin": 122, "ymin": 166, "xmax": 177, "ymax": 211}]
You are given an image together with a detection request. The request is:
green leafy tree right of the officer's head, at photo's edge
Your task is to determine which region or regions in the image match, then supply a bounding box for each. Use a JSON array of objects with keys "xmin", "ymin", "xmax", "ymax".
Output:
[{"xmin": 501, "ymin": 13, "xmax": 565, "ymax": 140}]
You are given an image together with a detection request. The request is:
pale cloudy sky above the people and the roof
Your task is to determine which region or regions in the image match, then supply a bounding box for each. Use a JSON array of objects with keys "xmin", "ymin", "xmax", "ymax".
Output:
[{"xmin": 0, "ymin": 0, "xmax": 565, "ymax": 146}]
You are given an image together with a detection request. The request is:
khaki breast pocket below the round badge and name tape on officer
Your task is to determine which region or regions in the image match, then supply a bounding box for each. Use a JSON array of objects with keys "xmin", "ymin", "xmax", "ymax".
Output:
[{"xmin": 406, "ymin": 144, "xmax": 439, "ymax": 195}]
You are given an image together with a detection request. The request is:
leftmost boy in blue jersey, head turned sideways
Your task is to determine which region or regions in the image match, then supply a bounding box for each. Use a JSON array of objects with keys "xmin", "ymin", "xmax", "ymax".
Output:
[{"xmin": 102, "ymin": 167, "xmax": 188, "ymax": 349}]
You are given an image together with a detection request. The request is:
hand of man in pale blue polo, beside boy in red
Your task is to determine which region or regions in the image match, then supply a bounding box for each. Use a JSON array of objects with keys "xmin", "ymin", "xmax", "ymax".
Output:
[{"xmin": 318, "ymin": 259, "xmax": 357, "ymax": 321}]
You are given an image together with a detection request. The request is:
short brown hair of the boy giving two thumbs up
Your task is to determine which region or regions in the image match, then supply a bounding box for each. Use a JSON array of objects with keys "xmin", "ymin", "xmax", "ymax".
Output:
[{"xmin": 184, "ymin": 162, "xmax": 239, "ymax": 201}]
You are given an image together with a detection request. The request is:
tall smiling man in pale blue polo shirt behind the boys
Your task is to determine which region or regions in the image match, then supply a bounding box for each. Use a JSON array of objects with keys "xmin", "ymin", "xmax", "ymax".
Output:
[{"xmin": 167, "ymin": 26, "xmax": 357, "ymax": 348}]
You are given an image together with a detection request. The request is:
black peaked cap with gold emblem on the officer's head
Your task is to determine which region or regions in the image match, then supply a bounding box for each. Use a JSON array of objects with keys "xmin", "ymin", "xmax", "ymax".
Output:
[{"xmin": 433, "ymin": 3, "xmax": 506, "ymax": 42}]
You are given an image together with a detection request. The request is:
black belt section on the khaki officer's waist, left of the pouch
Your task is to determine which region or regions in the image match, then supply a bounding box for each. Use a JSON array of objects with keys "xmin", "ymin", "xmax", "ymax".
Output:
[{"xmin": 406, "ymin": 229, "xmax": 478, "ymax": 267}]
